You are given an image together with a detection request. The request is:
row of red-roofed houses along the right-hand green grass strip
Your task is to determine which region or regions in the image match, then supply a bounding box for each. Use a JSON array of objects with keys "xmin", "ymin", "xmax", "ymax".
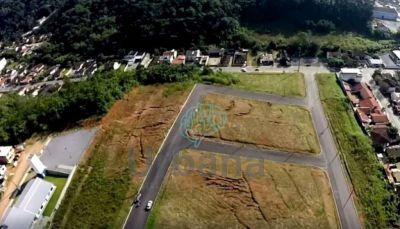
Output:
[{"xmin": 338, "ymin": 68, "xmax": 400, "ymax": 193}]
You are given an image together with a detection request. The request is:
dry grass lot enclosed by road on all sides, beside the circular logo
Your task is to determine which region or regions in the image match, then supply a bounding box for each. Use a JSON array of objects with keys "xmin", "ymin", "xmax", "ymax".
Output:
[{"xmin": 191, "ymin": 94, "xmax": 320, "ymax": 154}]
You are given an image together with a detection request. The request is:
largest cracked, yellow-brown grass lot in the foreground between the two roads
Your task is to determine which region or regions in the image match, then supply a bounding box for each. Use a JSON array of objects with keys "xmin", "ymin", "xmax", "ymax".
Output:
[{"xmin": 147, "ymin": 151, "xmax": 339, "ymax": 229}]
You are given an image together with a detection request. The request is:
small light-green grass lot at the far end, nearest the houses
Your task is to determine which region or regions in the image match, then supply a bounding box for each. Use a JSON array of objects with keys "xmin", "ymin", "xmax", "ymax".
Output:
[{"xmin": 233, "ymin": 73, "xmax": 306, "ymax": 97}]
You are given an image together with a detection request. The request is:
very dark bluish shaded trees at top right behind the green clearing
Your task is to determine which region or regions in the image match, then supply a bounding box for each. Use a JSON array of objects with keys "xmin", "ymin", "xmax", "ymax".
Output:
[{"xmin": 243, "ymin": 0, "xmax": 374, "ymax": 33}]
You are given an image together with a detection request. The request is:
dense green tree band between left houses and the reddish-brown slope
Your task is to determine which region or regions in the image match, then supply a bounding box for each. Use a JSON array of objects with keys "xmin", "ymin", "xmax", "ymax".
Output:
[{"xmin": 0, "ymin": 65, "xmax": 235, "ymax": 144}]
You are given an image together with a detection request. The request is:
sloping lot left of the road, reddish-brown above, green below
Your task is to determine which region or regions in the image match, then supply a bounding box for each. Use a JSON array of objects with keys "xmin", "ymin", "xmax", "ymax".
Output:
[{"xmin": 53, "ymin": 83, "xmax": 193, "ymax": 228}]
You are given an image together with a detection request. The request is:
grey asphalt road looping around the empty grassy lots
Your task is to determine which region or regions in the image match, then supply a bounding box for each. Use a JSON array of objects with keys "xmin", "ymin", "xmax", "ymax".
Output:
[{"xmin": 124, "ymin": 72, "xmax": 361, "ymax": 229}]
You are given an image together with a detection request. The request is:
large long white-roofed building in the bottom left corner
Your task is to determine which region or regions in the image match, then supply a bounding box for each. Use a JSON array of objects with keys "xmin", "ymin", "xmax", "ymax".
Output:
[{"xmin": 1, "ymin": 178, "xmax": 56, "ymax": 229}]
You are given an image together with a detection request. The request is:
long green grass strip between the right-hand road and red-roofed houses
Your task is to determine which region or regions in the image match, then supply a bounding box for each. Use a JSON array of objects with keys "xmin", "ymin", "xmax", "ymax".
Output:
[{"xmin": 317, "ymin": 74, "xmax": 396, "ymax": 228}]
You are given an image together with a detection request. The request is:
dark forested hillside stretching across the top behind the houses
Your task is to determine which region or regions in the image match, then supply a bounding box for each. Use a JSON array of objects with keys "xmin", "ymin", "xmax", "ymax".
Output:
[{"xmin": 0, "ymin": 0, "xmax": 373, "ymax": 63}]
